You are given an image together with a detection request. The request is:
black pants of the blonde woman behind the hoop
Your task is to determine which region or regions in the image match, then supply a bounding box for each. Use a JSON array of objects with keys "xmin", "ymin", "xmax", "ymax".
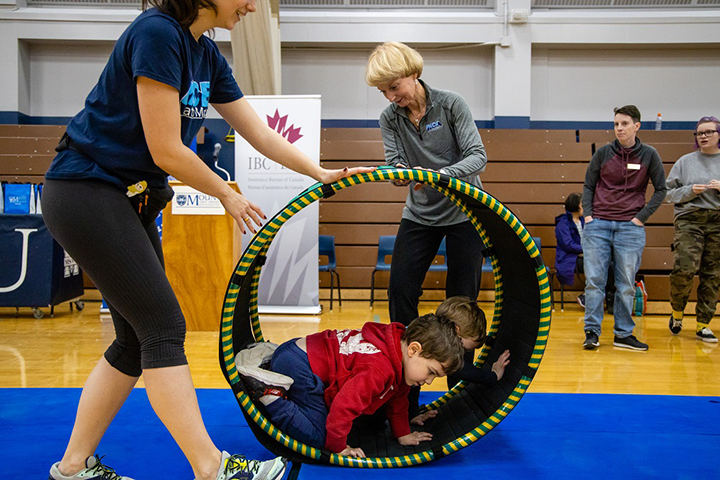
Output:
[{"xmin": 388, "ymin": 218, "xmax": 483, "ymax": 325}]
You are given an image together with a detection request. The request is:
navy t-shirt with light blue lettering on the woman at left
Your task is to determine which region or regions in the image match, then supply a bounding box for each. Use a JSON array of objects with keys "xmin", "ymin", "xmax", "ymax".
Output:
[{"xmin": 45, "ymin": 8, "xmax": 243, "ymax": 190}]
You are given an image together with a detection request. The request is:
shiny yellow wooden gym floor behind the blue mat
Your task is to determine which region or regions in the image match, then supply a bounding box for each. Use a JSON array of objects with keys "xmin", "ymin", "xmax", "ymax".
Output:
[{"xmin": 0, "ymin": 301, "xmax": 720, "ymax": 396}]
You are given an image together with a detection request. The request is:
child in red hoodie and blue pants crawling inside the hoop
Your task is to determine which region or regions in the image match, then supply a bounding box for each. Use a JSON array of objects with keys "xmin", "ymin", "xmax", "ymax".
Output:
[{"xmin": 236, "ymin": 314, "xmax": 464, "ymax": 457}]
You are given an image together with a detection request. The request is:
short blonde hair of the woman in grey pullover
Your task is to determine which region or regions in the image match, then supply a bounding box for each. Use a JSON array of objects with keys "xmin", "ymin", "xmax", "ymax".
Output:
[{"xmin": 365, "ymin": 42, "xmax": 423, "ymax": 87}]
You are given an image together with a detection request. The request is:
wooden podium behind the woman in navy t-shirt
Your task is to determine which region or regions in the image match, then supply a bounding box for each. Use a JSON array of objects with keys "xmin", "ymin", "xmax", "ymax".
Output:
[{"xmin": 162, "ymin": 182, "xmax": 242, "ymax": 331}]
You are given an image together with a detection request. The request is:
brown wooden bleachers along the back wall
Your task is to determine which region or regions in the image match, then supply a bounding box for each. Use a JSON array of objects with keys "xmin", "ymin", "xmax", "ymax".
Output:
[{"xmin": 0, "ymin": 125, "xmax": 695, "ymax": 301}]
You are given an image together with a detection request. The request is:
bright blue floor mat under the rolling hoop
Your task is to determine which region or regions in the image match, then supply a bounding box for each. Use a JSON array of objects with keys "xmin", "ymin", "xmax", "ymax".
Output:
[{"xmin": 0, "ymin": 388, "xmax": 720, "ymax": 480}]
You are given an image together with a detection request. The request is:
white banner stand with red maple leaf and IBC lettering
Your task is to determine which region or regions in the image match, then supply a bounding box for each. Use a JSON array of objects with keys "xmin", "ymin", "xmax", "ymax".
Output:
[{"xmin": 235, "ymin": 95, "xmax": 320, "ymax": 315}]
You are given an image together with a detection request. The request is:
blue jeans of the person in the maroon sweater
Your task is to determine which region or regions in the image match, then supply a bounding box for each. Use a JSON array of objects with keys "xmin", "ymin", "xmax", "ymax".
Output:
[{"xmin": 582, "ymin": 218, "xmax": 645, "ymax": 338}]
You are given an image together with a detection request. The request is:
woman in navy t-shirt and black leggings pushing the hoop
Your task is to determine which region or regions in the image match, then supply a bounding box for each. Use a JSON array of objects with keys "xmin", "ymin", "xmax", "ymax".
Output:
[{"xmin": 42, "ymin": 0, "xmax": 369, "ymax": 480}]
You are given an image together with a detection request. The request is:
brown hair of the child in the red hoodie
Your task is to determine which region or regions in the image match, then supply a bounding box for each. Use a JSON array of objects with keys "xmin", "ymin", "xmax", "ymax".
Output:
[{"xmin": 402, "ymin": 313, "xmax": 465, "ymax": 375}]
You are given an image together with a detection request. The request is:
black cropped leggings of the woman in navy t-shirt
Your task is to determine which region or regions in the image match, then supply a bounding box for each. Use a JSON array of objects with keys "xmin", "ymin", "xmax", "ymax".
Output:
[{"xmin": 42, "ymin": 180, "xmax": 187, "ymax": 377}]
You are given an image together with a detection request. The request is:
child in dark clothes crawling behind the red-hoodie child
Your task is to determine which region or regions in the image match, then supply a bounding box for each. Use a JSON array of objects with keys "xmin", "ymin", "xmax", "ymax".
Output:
[{"xmin": 409, "ymin": 296, "xmax": 510, "ymax": 425}]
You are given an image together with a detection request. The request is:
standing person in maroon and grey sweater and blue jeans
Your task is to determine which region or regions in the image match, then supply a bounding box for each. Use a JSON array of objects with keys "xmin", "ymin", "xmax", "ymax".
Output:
[{"xmin": 582, "ymin": 105, "xmax": 667, "ymax": 351}]
